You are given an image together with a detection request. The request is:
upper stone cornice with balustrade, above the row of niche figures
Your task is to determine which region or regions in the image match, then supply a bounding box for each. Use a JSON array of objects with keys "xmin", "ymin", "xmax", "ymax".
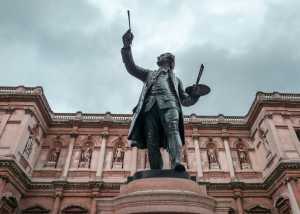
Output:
[{"xmin": 0, "ymin": 86, "xmax": 300, "ymax": 129}]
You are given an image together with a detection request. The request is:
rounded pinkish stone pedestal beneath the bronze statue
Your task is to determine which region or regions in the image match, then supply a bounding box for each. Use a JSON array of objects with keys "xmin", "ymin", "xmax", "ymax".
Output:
[{"xmin": 97, "ymin": 170, "xmax": 231, "ymax": 214}]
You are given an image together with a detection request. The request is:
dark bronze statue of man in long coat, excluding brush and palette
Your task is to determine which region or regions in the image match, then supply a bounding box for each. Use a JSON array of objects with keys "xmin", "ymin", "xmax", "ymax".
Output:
[{"xmin": 121, "ymin": 30, "xmax": 200, "ymax": 171}]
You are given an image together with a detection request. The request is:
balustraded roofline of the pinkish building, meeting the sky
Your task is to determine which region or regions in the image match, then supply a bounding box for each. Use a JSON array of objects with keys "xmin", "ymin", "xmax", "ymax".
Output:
[{"xmin": 0, "ymin": 86, "xmax": 300, "ymax": 125}]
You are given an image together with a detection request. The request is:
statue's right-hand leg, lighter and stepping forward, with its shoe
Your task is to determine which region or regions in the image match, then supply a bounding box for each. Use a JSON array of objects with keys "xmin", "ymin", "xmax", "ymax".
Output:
[{"xmin": 161, "ymin": 108, "xmax": 184, "ymax": 170}]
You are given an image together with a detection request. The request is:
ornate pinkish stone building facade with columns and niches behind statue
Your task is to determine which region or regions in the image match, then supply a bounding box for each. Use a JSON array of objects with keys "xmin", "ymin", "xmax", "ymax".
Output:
[{"xmin": 0, "ymin": 86, "xmax": 300, "ymax": 214}]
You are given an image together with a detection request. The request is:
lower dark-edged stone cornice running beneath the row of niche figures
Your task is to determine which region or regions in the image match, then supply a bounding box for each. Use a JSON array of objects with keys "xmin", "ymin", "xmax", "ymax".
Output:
[{"xmin": 0, "ymin": 160, "xmax": 300, "ymax": 192}]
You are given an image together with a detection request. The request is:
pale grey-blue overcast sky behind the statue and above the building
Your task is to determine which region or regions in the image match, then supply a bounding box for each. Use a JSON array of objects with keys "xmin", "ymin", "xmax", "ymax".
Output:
[{"xmin": 0, "ymin": 0, "xmax": 300, "ymax": 115}]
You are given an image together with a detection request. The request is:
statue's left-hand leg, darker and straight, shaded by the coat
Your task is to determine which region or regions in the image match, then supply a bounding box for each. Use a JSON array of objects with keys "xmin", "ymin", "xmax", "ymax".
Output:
[{"xmin": 145, "ymin": 105, "xmax": 163, "ymax": 169}]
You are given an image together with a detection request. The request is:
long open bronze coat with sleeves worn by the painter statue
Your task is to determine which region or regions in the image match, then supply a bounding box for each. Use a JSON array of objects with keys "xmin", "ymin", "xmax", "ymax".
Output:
[{"xmin": 121, "ymin": 47, "xmax": 199, "ymax": 149}]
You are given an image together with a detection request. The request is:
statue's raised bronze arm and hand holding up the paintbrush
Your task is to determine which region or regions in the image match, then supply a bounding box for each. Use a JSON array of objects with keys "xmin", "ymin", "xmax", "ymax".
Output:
[{"xmin": 121, "ymin": 29, "xmax": 148, "ymax": 82}]
